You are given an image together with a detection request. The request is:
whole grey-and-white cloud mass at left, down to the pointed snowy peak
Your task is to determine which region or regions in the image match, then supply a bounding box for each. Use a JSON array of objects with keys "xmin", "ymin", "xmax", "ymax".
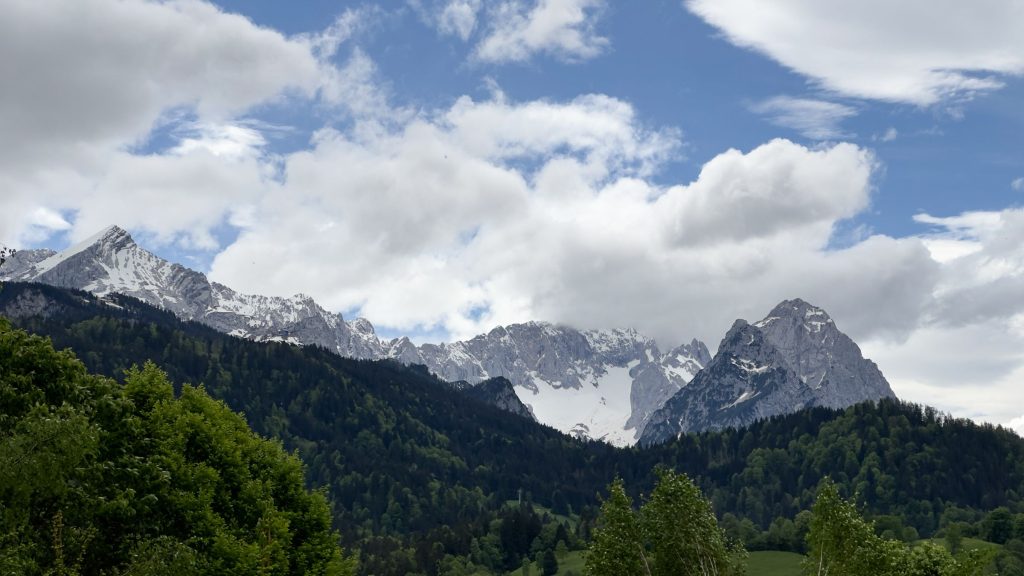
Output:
[{"xmin": 0, "ymin": 0, "xmax": 366, "ymax": 243}]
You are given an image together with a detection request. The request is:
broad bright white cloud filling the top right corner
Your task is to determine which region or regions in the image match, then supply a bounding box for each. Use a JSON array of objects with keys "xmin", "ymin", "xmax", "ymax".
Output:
[{"xmin": 686, "ymin": 0, "xmax": 1024, "ymax": 105}]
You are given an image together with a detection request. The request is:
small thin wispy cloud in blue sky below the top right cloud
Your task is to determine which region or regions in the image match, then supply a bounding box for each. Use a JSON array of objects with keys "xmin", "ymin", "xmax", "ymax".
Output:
[{"xmin": 751, "ymin": 96, "xmax": 857, "ymax": 140}]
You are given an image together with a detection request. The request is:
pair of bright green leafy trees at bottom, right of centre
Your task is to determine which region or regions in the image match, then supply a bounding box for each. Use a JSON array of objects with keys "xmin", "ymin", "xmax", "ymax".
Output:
[{"xmin": 587, "ymin": 469, "xmax": 745, "ymax": 576}]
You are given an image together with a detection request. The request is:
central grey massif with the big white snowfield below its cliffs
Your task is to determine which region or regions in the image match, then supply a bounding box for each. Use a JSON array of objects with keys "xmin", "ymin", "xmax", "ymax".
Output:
[{"xmin": 389, "ymin": 322, "xmax": 711, "ymax": 446}]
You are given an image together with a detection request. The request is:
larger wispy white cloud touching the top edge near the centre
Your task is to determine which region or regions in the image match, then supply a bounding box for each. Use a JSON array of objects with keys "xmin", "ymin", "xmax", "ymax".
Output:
[{"xmin": 474, "ymin": 0, "xmax": 608, "ymax": 64}]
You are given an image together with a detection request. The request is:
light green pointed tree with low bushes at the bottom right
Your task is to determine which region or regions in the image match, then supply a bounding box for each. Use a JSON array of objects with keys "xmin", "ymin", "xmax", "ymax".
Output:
[{"xmin": 804, "ymin": 479, "xmax": 992, "ymax": 576}]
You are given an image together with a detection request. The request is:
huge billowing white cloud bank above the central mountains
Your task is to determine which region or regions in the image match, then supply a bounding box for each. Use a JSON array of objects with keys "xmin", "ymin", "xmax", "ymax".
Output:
[{"xmin": 201, "ymin": 87, "xmax": 935, "ymax": 352}]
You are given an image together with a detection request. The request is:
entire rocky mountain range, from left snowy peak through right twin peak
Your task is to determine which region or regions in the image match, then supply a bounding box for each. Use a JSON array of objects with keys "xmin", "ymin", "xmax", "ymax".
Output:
[{"xmin": 0, "ymin": 227, "xmax": 893, "ymax": 446}]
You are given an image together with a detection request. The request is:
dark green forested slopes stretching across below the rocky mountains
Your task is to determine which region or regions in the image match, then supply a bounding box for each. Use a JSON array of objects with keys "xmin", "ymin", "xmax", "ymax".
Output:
[{"xmin": 6, "ymin": 284, "xmax": 1024, "ymax": 575}]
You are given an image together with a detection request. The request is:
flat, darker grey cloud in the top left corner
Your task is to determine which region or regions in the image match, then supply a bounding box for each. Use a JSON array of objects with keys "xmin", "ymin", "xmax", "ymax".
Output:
[{"xmin": 0, "ymin": 0, "xmax": 318, "ymax": 167}]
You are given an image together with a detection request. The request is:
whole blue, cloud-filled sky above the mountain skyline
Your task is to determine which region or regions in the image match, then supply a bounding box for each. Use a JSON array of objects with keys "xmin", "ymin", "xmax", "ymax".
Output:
[{"xmin": 0, "ymin": 0, "xmax": 1024, "ymax": 430}]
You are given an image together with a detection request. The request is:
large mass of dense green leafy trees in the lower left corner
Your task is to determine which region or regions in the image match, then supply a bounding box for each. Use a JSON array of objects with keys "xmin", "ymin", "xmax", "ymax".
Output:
[{"xmin": 0, "ymin": 319, "xmax": 354, "ymax": 576}]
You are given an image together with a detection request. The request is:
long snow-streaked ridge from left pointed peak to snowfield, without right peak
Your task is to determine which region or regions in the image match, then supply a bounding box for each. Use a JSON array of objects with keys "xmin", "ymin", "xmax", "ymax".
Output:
[{"xmin": 0, "ymin": 227, "xmax": 711, "ymax": 446}]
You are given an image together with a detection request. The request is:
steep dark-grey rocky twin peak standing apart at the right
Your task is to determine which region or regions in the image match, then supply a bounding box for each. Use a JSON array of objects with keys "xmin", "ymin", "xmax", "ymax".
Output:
[{"xmin": 640, "ymin": 299, "xmax": 895, "ymax": 445}]
